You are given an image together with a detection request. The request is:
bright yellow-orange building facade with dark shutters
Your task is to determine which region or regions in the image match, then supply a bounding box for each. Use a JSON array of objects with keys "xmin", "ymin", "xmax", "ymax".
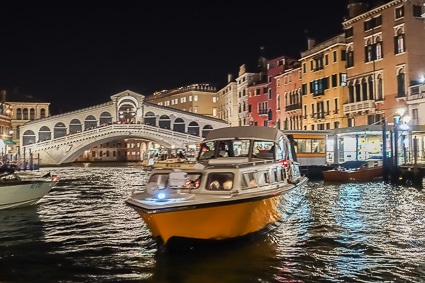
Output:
[{"xmin": 300, "ymin": 34, "xmax": 348, "ymax": 130}]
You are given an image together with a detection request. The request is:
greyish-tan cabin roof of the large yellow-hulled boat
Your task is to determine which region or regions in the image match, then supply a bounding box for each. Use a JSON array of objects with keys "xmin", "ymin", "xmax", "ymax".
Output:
[{"xmin": 204, "ymin": 126, "xmax": 285, "ymax": 142}]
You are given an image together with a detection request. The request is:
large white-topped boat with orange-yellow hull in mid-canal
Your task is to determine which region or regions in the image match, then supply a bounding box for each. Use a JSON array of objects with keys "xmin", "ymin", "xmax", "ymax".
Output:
[{"xmin": 126, "ymin": 126, "xmax": 307, "ymax": 244}]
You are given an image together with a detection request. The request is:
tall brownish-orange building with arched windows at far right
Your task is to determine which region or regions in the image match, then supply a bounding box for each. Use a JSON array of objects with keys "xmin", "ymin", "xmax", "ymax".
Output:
[{"xmin": 342, "ymin": 0, "xmax": 425, "ymax": 126}]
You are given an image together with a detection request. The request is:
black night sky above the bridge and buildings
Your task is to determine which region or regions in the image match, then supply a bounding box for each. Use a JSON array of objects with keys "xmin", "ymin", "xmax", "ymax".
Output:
[{"xmin": 0, "ymin": 0, "xmax": 372, "ymax": 112}]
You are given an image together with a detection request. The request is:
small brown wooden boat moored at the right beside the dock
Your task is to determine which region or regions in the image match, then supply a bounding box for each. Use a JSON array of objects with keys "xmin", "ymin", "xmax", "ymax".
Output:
[{"xmin": 323, "ymin": 161, "xmax": 384, "ymax": 182}]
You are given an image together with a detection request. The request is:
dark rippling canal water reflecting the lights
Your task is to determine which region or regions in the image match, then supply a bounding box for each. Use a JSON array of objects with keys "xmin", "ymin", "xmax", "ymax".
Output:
[{"xmin": 0, "ymin": 166, "xmax": 425, "ymax": 283}]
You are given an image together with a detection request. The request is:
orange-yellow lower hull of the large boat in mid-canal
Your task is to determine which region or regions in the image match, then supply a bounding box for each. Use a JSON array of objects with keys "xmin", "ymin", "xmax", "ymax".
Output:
[{"xmin": 132, "ymin": 195, "xmax": 284, "ymax": 243}]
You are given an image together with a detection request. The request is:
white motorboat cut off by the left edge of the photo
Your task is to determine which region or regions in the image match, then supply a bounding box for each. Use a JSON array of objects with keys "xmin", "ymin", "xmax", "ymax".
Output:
[{"xmin": 0, "ymin": 172, "xmax": 59, "ymax": 209}]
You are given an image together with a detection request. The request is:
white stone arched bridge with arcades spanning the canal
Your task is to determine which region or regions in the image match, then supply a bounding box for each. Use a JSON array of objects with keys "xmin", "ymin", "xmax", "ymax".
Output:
[{"xmin": 20, "ymin": 90, "xmax": 228, "ymax": 166}]
